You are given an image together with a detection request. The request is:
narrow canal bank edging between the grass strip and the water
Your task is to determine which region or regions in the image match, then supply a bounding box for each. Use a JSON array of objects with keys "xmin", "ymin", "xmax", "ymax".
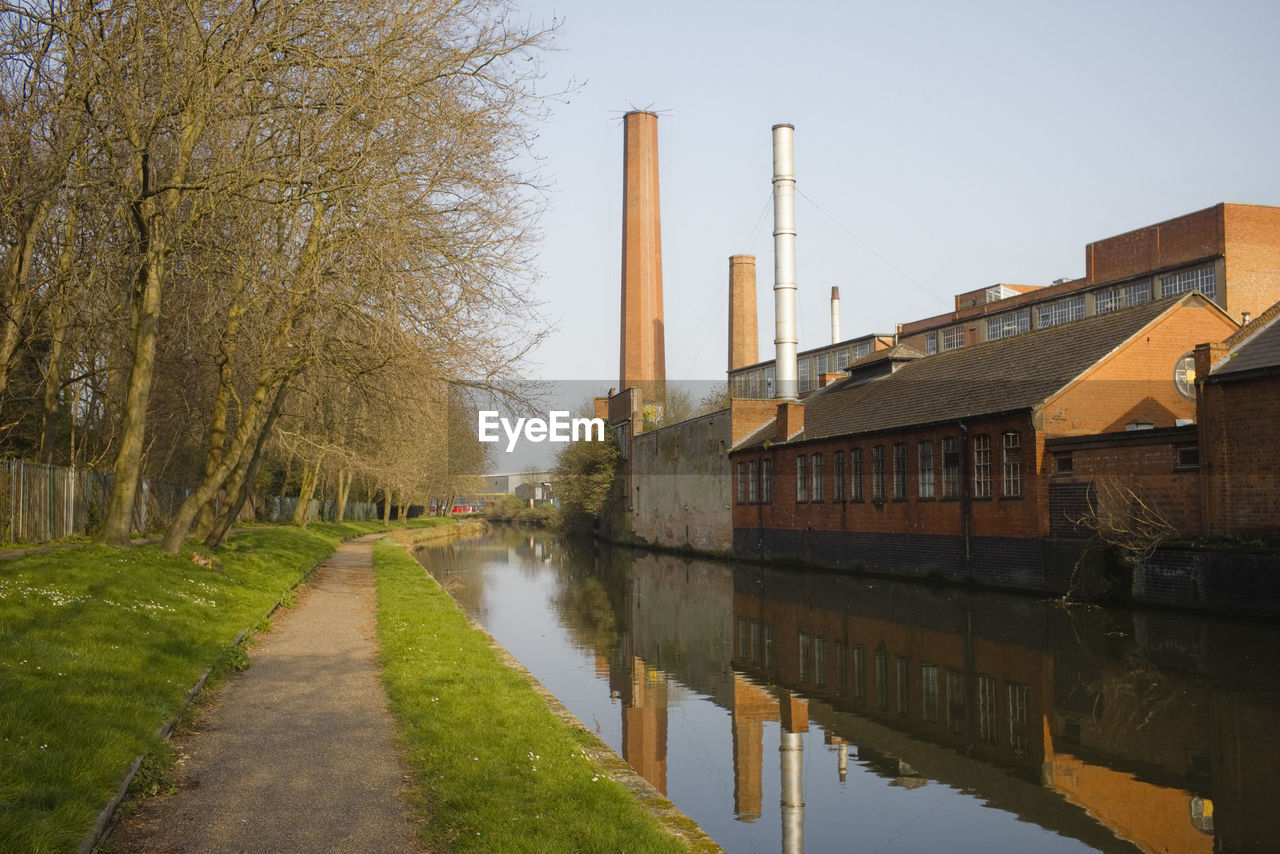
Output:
[{"xmin": 394, "ymin": 535, "xmax": 724, "ymax": 854}]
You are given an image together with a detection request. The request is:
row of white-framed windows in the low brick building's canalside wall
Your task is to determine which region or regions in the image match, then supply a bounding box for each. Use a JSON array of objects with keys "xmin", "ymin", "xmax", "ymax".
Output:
[{"xmin": 737, "ymin": 430, "xmax": 1023, "ymax": 504}]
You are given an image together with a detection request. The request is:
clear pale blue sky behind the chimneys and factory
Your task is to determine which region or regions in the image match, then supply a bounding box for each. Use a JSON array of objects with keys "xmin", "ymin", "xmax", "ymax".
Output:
[{"xmin": 521, "ymin": 0, "xmax": 1280, "ymax": 387}]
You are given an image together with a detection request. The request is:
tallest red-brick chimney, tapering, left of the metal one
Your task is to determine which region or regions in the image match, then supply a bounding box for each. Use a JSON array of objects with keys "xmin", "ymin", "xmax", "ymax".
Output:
[{"xmin": 620, "ymin": 111, "xmax": 667, "ymax": 405}]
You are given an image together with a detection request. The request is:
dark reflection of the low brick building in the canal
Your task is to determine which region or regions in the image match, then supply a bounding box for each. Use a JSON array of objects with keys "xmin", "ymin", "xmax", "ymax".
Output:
[{"xmin": 733, "ymin": 570, "xmax": 1280, "ymax": 854}]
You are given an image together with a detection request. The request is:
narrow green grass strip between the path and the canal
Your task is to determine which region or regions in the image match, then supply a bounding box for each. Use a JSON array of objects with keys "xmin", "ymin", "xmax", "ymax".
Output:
[{"xmin": 374, "ymin": 543, "xmax": 686, "ymax": 854}]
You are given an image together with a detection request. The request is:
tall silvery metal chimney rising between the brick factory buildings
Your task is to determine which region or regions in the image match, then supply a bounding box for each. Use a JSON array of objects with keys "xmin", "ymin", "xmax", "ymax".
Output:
[{"xmin": 773, "ymin": 124, "xmax": 800, "ymax": 401}]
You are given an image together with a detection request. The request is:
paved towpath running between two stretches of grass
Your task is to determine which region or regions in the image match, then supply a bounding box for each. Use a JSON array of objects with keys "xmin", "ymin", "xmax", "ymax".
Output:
[{"xmin": 109, "ymin": 534, "xmax": 421, "ymax": 854}]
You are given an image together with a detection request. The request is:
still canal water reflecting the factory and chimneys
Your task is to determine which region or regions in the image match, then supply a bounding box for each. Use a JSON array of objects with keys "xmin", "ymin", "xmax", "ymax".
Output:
[{"xmin": 417, "ymin": 530, "xmax": 1280, "ymax": 854}]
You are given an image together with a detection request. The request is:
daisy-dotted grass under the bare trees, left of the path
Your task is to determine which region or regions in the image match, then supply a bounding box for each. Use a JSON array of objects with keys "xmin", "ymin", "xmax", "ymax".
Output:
[{"xmin": 0, "ymin": 525, "xmax": 379, "ymax": 853}]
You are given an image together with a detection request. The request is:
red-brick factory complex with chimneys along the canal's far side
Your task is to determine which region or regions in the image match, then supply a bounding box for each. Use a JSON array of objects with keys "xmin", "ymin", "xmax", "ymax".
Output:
[{"xmin": 598, "ymin": 113, "xmax": 1280, "ymax": 607}]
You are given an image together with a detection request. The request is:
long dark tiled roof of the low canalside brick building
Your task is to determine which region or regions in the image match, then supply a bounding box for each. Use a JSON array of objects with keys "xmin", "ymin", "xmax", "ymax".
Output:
[{"xmin": 798, "ymin": 294, "xmax": 1207, "ymax": 444}]
